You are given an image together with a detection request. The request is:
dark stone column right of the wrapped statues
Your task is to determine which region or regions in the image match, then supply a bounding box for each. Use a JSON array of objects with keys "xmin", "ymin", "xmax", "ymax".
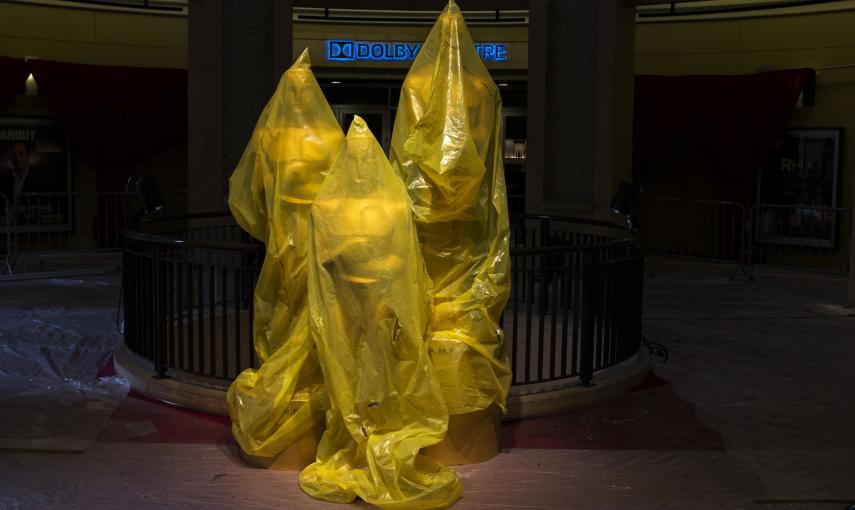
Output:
[{"xmin": 526, "ymin": 0, "xmax": 635, "ymax": 217}]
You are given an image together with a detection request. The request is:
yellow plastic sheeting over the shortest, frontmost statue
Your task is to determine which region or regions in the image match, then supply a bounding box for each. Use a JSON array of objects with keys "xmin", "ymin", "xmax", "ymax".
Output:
[{"xmin": 300, "ymin": 117, "xmax": 461, "ymax": 510}]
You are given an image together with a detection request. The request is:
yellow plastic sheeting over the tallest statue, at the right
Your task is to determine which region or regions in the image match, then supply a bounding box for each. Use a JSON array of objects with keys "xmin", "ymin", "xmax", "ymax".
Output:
[{"xmin": 390, "ymin": 2, "xmax": 511, "ymax": 414}]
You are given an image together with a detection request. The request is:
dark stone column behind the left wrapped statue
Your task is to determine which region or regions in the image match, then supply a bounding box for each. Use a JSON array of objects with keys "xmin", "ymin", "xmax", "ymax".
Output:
[{"xmin": 187, "ymin": 0, "xmax": 292, "ymax": 212}]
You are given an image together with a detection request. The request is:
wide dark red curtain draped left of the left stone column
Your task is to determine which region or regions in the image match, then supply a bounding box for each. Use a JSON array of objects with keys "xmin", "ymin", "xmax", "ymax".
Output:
[{"xmin": 32, "ymin": 60, "xmax": 187, "ymax": 191}]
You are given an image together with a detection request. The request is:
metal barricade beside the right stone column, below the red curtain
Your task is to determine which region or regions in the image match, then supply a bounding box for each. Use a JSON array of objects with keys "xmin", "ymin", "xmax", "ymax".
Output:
[{"xmin": 640, "ymin": 197, "xmax": 751, "ymax": 268}]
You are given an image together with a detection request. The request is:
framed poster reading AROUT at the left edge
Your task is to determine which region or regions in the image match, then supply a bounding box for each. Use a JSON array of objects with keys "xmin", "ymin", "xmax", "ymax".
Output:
[{"xmin": 0, "ymin": 117, "xmax": 71, "ymax": 232}]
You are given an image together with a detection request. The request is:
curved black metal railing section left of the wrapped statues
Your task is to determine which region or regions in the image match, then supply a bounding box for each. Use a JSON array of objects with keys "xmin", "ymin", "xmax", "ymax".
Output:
[{"xmin": 123, "ymin": 213, "xmax": 264, "ymax": 379}]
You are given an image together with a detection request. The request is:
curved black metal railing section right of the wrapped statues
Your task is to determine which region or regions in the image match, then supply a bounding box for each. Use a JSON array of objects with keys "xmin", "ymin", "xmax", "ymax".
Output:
[{"xmin": 501, "ymin": 215, "xmax": 644, "ymax": 385}]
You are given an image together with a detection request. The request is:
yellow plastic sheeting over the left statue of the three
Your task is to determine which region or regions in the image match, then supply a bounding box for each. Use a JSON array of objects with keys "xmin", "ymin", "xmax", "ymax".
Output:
[{"xmin": 227, "ymin": 50, "xmax": 344, "ymax": 457}]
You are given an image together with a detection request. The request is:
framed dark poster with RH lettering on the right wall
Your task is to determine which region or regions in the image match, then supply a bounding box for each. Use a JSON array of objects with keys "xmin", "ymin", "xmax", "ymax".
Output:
[{"xmin": 756, "ymin": 128, "xmax": 843, "ymax": 247}]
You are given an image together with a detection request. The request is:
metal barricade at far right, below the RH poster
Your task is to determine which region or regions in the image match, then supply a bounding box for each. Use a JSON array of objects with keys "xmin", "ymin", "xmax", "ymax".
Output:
[{"xmin": 751, "ymin": 204, "xmax": 853, "ymax": 274}]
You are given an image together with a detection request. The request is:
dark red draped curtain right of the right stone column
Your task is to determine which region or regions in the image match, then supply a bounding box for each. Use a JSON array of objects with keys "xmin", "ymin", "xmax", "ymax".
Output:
[{"xmin": 633, "ymin": 69, "xmax": 814, "ymax": 185}]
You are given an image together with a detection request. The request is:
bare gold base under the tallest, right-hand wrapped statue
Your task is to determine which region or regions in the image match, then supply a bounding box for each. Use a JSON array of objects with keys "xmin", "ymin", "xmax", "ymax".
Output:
[{"xmin": 422, "ymin": 404, "xmax": 502, "ymax": 466}]
